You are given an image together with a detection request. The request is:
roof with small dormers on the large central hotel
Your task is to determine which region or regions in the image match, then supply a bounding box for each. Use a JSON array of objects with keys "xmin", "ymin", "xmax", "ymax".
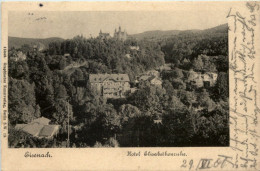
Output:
[{"xmin": 89, "ymin": 74, "xmax": 130, "ymax": 83}]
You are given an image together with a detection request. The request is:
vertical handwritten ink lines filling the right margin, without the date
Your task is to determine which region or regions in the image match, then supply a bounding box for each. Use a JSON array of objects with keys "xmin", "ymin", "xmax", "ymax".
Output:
[{"xmin": 227, "ymin": 2, "xmax": 260, "ymax": 169}]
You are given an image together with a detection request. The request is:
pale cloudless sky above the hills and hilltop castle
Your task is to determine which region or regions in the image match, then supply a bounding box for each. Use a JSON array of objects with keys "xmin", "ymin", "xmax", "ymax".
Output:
[{"xmin": 8, "ymin": 8, "xmax": 229, "ymax": 39}]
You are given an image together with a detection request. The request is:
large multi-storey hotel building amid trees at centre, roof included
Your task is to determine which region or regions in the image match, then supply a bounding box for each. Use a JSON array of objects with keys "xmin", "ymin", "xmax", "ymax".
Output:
[{"xmin": 89, "ymin": 74, "xmax": 131, "ymax": 98}]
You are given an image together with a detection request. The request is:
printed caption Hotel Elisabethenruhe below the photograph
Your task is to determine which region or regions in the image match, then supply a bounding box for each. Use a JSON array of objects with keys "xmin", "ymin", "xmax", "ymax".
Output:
[{"xmin": 127, "ymin": 151, "xmax": 187, "ymax": 156}]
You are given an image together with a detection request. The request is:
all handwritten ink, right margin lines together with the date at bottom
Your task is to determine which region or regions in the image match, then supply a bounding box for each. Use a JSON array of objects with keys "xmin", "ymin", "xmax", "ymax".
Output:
[{"xmin": 181, "ymin": 2, "xmax": 260, "ymax": 170}]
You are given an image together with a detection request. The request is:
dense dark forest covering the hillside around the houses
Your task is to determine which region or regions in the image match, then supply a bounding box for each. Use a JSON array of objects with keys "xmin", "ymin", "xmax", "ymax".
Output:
[{"xmin": 8, "ymin": 23, "xmax": 229, "ymax": 147}]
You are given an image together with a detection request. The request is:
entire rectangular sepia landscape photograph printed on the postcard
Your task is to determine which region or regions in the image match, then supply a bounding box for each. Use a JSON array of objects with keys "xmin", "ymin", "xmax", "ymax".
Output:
[{"xmin": 8, "ymin": 11, "xmax": 229, "ymax": 148}]
